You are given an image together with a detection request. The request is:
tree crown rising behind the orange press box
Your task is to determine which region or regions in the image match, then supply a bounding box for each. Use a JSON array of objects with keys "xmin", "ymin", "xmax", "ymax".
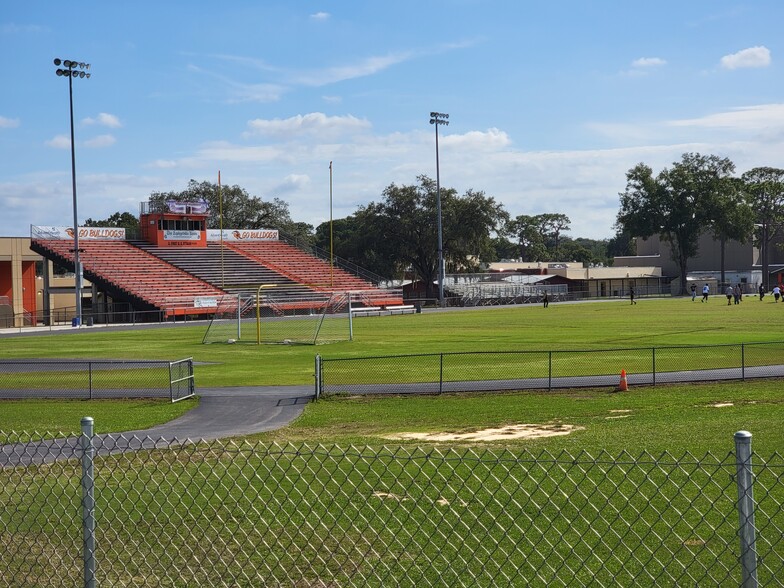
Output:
[{"xmin": 149, "ymin": 180, "xmax": 313, "ymax": 243}]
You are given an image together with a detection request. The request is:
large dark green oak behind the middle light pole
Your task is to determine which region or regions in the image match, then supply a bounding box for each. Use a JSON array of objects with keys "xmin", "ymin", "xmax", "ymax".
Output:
[{"xmin": 346, "ymin": 175, "xmax": 506, "ymax": 297}]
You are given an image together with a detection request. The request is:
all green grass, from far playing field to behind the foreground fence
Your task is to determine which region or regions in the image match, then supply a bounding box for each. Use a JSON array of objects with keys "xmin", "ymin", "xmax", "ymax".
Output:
[{"xmin": 0, "ymin": 298, "xmax": 784, "ymax": 587}]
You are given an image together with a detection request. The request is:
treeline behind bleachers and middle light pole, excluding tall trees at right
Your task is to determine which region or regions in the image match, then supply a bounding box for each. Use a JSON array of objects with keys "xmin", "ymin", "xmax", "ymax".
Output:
[{"xmin": 85, "ymin": 175, "xmax": 631, "ymax": 295}]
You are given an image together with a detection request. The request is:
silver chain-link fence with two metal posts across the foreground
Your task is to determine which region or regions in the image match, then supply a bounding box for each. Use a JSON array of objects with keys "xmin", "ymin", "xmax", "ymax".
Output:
[{"xmin": 0, "ymin": 418, "xmax": 784, "ymax": 588}]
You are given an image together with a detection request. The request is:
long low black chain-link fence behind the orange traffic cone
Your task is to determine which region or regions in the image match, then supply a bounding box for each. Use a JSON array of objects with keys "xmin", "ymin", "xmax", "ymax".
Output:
[{"xmin": 315, "ymin": 341, "xmax": 784, "ymax": 396}]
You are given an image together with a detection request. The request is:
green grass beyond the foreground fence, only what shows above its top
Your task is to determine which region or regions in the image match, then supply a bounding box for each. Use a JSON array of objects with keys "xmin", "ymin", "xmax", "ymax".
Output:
[{"xmin": 0, "ymin": 297, "xmax": 784, "ymax": 451}]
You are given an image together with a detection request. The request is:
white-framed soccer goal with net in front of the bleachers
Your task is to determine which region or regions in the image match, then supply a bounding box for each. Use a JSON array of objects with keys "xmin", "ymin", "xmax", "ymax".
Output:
[{"xmin": 202, "ymin": 290, "xmax": 351, "ymax": 345}]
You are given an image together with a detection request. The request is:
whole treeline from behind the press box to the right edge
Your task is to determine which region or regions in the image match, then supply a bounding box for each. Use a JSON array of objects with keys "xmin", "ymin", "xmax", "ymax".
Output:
[{"xmin": 95, "ymin": 153, "xmax": 784, "ymax": 294}]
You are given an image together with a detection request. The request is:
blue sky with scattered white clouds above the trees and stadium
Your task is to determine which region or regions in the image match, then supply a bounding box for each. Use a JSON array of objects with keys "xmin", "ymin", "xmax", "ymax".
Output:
[{"xmin": 0, "ymin": 0, "xmax": 784, "ymax": 238}]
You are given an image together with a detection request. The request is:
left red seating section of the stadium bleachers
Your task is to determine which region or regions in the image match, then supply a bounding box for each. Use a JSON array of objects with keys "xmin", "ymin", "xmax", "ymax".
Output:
[{"xmin": 31, "ymin": 239, "xmax": 224, "ymax": 316}]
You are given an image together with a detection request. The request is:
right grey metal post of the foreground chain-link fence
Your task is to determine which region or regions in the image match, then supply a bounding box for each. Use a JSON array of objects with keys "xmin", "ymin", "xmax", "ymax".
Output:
[{"xmin": 735, "ymin": 431, "xmax": 759, "ymax": 588}]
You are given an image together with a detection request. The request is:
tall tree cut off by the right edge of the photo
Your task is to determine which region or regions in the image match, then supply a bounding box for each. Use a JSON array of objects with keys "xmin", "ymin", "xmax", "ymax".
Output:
[{"xmin": 741, "ymin": 167, "xmax": 784, "ymax": 286}]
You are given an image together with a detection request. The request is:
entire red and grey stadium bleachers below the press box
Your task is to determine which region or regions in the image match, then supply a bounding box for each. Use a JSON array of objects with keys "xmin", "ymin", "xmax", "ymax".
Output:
[{"xmin": 31, "ymin": 234, "xmax": 403, "ymax": 316}]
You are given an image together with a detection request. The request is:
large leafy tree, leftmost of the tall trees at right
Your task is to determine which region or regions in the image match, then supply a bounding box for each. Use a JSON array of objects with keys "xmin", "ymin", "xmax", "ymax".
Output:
[{"xmin": 616, "ymin": 153, "xmax": 735, "ymax": 294}]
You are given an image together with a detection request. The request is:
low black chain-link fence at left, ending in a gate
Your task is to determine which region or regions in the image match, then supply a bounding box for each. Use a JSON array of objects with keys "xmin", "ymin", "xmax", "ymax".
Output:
[{"xmin": 0, "ymin": 358, "xmax": 195, "ymax": 402}]
